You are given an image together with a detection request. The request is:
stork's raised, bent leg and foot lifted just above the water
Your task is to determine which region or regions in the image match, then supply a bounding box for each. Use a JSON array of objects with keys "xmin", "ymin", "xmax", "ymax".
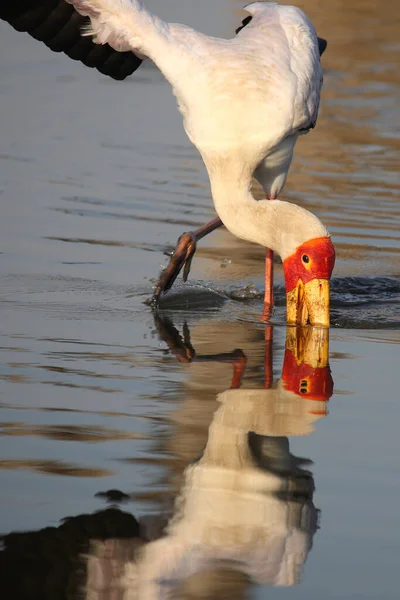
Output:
[{"xmin": 152, "ymin": 217, "xmax": 223, "ymax": 305}]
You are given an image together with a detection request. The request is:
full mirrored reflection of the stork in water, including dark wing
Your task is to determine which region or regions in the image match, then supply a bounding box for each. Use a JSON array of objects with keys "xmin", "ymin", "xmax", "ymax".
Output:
[{"xmin": 0, "ymin": 322, "xmax": 333, "ymax": 600}]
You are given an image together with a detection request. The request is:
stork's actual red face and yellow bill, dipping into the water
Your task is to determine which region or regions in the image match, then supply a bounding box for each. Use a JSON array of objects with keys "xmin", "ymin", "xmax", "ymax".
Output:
[{"xmin": 283, "ymin": 236, "xmax": 335, "ymax": 327}]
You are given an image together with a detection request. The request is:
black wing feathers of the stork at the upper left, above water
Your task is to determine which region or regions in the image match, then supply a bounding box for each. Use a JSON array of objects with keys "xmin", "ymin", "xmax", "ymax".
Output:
[{"xmin": 0, "ymin": 0, "xmax": 142, "ymax": 80}]
